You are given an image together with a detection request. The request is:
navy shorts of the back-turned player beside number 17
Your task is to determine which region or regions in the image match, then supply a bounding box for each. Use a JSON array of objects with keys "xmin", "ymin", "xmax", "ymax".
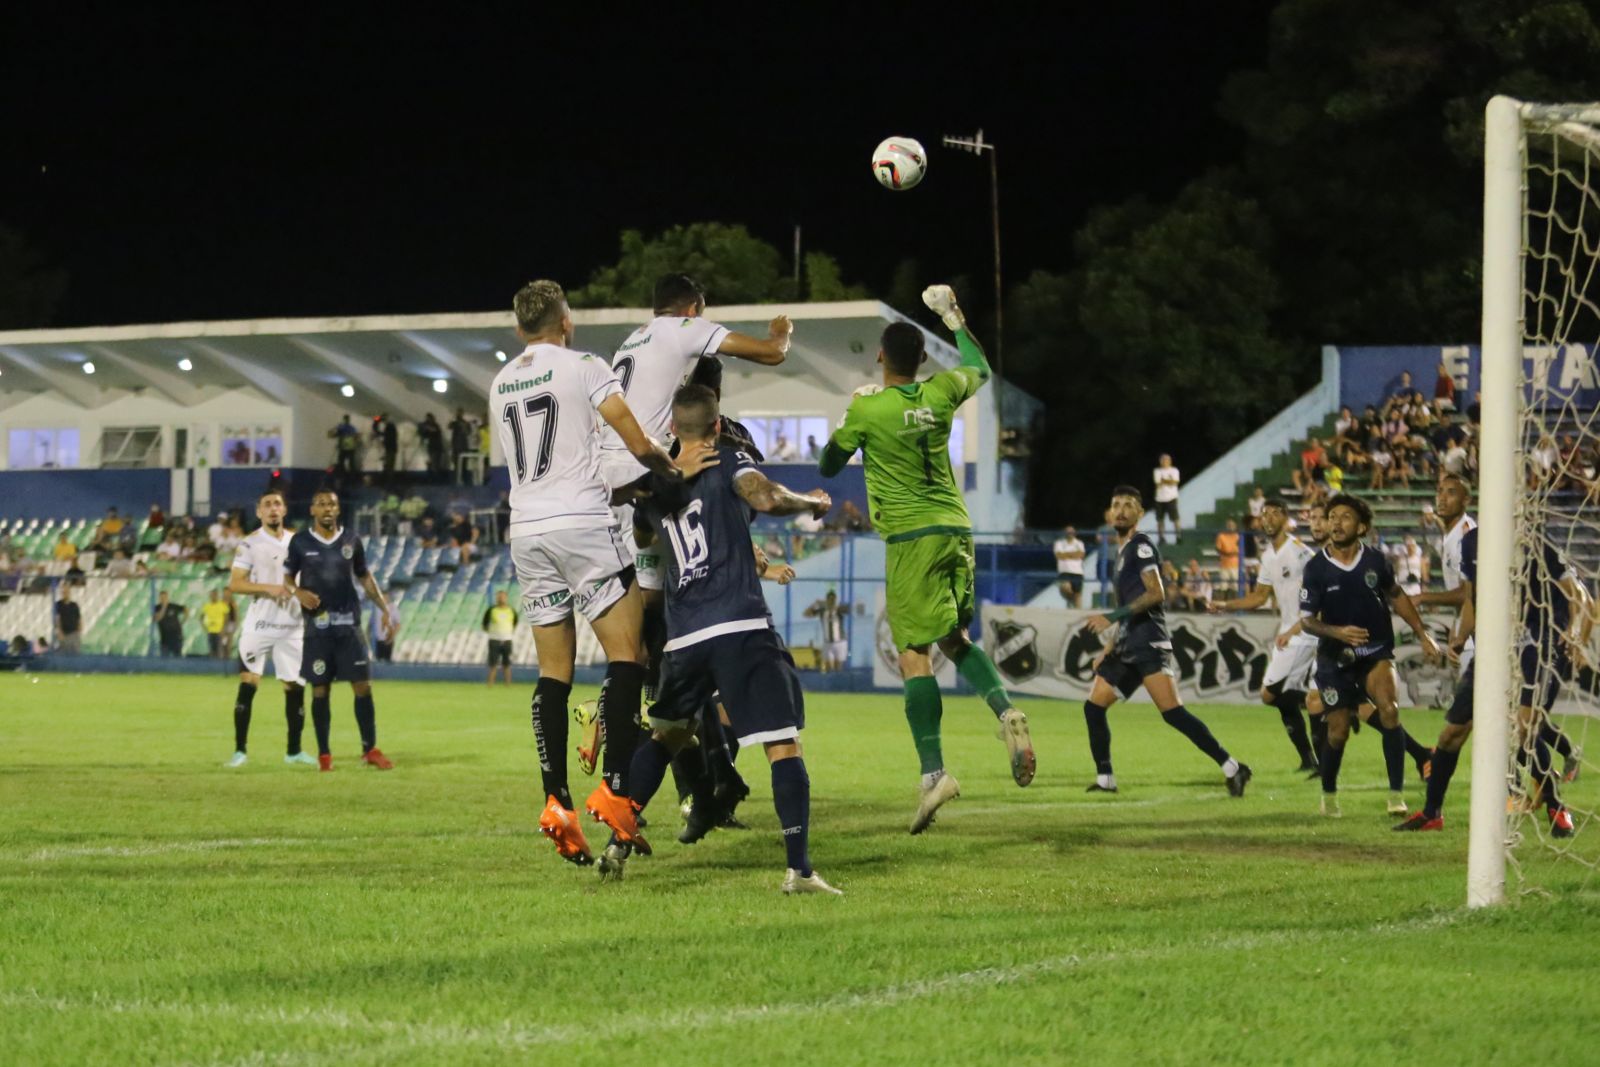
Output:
[{"xmin": 650, "ymin": 627, "xmax": 805, "ymax": 745}]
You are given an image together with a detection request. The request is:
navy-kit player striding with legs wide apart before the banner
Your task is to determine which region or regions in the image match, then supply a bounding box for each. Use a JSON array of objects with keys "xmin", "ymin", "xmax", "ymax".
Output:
[{"xmin": 1083, "ymin": 485, "xmax": 1251, "ymax": 797}]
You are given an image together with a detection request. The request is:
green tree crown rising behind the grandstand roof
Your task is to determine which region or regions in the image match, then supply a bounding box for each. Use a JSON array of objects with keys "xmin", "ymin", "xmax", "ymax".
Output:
[{"xmin": 568, "ymin": 222, "xmax": 866, "ymax": 307}]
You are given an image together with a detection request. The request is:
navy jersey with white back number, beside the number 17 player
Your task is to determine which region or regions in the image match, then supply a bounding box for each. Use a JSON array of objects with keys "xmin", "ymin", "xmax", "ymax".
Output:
[{"xmin": 634, "ymin": 445, "xmax": 771, "ymax": 651}]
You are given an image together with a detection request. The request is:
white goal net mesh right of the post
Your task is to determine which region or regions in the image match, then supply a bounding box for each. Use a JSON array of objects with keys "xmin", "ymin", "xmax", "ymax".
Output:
[{"xmin": 1501, "ymin": 117, "xmax": 1600, "ymax": 893}]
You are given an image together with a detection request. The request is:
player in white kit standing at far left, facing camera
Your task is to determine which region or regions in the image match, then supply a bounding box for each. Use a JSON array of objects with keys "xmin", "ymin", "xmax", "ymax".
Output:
[{"xmin": 227, "ymin": 490, "xmax": 317, "ymax": 766}]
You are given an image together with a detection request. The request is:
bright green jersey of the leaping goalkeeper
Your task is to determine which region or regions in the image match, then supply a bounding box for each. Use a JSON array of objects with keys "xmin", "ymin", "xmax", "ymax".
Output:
[{"xmin": 824, "ymin": 364, "xmax": 989, "ymax": 542}]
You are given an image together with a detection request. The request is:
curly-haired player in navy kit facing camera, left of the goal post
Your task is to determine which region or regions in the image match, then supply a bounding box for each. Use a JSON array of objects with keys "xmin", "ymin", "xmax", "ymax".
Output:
[{"xmin": 1301, "ymin": 493, "xmax": 1438, "ymax": 817}]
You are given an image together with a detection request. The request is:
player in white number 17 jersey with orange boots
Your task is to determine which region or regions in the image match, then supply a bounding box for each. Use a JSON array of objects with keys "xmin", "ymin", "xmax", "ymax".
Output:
[{"xmin": 490, "ymin": 282, "xmax": 704, "ymax": 865}]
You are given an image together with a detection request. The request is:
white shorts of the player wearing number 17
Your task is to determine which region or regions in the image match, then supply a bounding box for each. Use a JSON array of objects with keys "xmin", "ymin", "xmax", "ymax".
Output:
[{"xmin": 510, "ymin": 526, "xmax": 632, "ymax": 625}]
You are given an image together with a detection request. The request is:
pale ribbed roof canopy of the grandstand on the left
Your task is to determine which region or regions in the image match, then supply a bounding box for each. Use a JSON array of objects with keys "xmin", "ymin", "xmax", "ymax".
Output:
[{"xmin": 0, "ymin": 301, "xmax": 958, "ymax": 419}]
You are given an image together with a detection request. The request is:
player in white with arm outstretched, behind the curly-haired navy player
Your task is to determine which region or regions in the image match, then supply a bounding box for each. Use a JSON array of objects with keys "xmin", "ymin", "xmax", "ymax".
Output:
[{"xmin": 1210, "ymin": 498, "xmax": 1317, "ymax": 771}]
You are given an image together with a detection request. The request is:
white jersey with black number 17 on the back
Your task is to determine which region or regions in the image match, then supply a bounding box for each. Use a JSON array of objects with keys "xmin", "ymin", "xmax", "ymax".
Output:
[{"xmin": 490, "ymin": 344, "xmax": 622, "ymax": 537}]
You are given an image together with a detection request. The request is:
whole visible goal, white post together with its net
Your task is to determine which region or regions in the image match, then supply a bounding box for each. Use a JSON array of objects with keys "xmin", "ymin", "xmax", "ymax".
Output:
[{"xmin": 1467, "ymin": 98, "xmax": 1600, "ymax": 905}]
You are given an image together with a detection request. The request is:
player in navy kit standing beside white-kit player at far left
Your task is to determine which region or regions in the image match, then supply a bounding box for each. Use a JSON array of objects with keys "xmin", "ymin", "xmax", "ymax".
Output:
[{"xmin": 283, "ymin": 490, "xmax": 394, "ymax": 771}]
